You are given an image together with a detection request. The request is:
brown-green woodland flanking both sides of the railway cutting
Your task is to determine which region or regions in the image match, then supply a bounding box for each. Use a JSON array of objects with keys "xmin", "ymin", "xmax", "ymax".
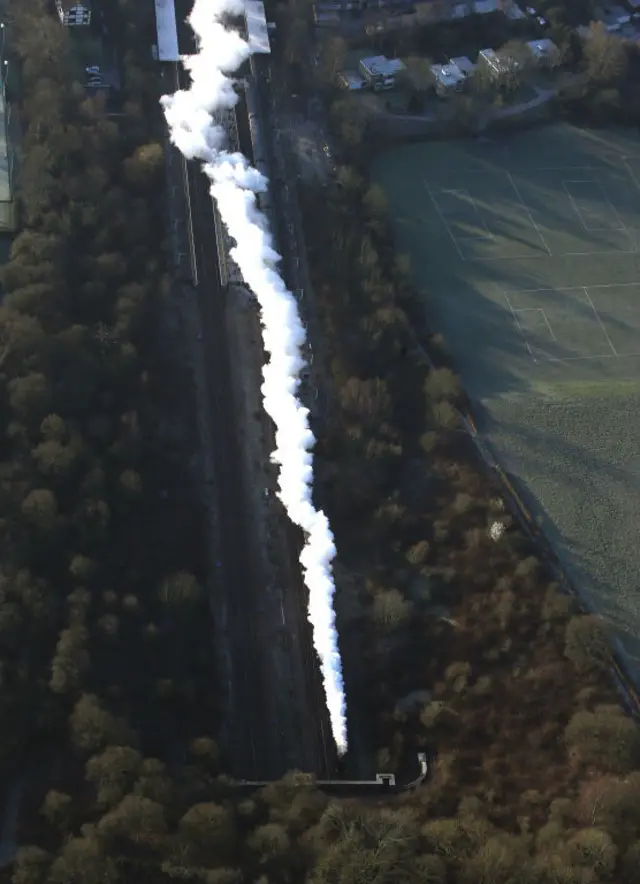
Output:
[{"xmin": 0, "ymin": 0, "xmax": 640, "ymax": 884}]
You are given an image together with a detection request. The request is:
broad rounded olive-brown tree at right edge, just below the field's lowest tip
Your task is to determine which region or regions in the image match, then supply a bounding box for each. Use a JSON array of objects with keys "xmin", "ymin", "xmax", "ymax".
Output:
[{"xmin": 564, "ymin": 709, "xmax": 640, "ymax": 773}]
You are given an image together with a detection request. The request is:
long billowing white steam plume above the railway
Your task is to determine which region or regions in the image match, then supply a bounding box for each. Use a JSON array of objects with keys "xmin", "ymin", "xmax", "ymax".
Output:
[{"xmin": 162, "ymin": 0, "xmax": 347, "ymax": 754}]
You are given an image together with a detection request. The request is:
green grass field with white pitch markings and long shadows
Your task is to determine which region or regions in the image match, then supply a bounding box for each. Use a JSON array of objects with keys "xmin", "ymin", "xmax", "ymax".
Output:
[{"xmin": 373, "ymin": 124, "xmax": 640, "ymax": 681}]
